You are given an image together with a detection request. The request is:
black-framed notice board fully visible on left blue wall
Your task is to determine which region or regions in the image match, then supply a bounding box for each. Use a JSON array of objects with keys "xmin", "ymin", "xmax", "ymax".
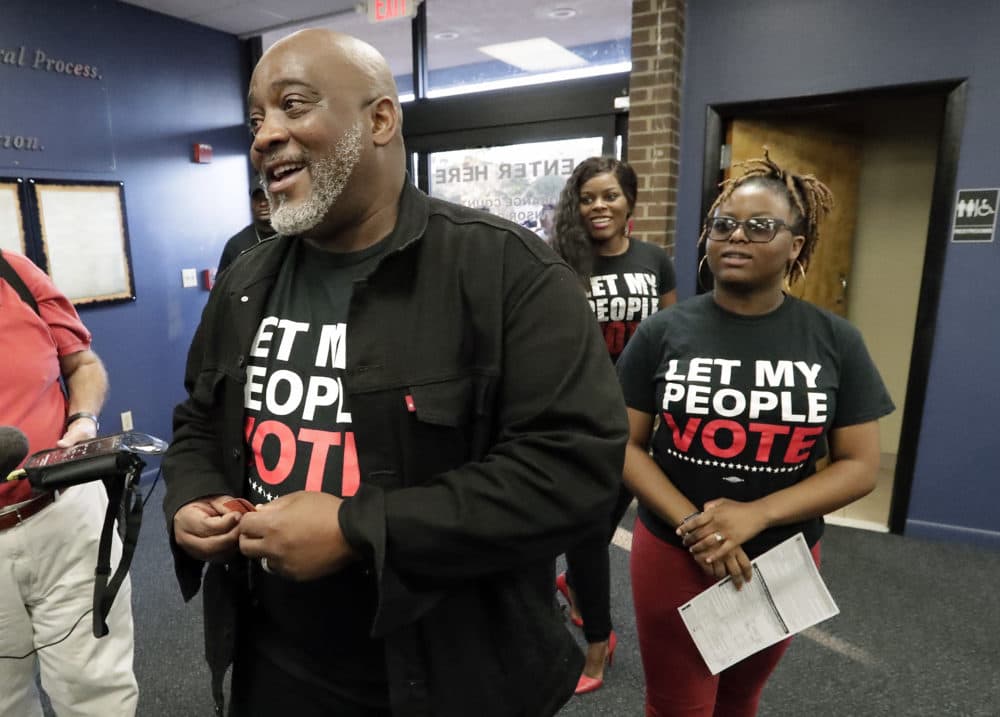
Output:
[{"xmin": 28, "ymin": 179, "xmax": 135, "ymax": 305}]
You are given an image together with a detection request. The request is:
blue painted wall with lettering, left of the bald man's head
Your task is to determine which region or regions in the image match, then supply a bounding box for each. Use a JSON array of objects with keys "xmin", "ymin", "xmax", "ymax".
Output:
[{"xmin": 0, "ymin": 0, "xmax": 250, "ymax": 456}]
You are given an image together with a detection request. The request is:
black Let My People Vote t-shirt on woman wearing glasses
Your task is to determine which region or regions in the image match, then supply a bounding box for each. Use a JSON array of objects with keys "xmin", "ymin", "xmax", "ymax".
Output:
[{"xmin": 617, "ymin": 294, "xmax": 893, "ymax": 558}]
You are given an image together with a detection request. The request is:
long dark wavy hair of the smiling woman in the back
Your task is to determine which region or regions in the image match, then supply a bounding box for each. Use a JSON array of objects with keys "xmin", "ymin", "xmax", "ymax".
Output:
[{"xmin": 552, "ymin": 157, "xmax": 639, "ymax": 285}]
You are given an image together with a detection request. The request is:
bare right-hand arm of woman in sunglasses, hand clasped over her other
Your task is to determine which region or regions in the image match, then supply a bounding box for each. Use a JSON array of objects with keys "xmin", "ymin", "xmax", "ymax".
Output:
[{"xmin": 682, "ymin": 421, "xmax": 880, "ymax": 562}]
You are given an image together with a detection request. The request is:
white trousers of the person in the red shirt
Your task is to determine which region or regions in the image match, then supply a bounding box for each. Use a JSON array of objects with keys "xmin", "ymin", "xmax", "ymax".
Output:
[{"xmin": 0, "ymin": 481, "xmax": 139, "ymax": 717}]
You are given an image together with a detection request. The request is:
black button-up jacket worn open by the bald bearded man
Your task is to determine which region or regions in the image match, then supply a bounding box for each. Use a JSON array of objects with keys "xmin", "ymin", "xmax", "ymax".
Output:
[{"xmin": 163, "ymin": 184, "xmax": 628, "ymax": 717}]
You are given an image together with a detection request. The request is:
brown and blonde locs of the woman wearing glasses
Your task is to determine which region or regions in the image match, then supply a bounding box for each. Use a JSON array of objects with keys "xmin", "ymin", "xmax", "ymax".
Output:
[{"xmin": 698, "ymin": 147, "xmax": 833, "ymax": 285}]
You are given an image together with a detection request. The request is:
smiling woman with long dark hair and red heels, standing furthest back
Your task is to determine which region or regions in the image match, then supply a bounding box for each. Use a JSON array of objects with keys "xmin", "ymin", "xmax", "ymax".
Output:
[{"xmin": 552, "ymin": 157, "xmax": 677, "ymax": 694}]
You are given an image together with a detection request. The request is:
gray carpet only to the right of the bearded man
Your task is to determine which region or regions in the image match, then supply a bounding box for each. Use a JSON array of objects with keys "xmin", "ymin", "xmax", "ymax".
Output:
[{"xmin": 560, "ymin": 518, "xmax": 1000, "ymax": 717}]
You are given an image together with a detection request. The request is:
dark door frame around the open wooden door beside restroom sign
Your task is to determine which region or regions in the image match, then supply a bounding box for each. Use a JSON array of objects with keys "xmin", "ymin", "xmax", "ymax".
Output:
[{"xmin": 699, "ymin": 79, "xmax": 968, "ymax": 534}]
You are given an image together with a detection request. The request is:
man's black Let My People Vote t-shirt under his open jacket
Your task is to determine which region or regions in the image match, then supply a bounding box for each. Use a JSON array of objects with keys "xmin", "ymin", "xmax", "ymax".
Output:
[{"xmin": 244, "ymin": 239, "xmax": 387, "ymax": 707}]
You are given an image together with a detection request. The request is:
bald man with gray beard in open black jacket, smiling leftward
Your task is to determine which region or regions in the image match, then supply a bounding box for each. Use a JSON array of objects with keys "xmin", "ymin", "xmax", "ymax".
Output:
[{"xmin": 163, "ymin": 30, "xmax": 627, "ymax": 717}]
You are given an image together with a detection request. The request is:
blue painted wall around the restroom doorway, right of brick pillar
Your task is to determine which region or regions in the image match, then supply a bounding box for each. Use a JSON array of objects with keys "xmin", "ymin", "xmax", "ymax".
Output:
[{"xmin": 676, "ymin": 0, "xmax": 1000, "ymax": 545}]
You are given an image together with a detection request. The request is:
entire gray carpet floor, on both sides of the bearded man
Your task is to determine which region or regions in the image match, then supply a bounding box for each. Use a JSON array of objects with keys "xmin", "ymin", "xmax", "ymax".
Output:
[{"xmin": 48, "ymin": 478, "xmax": 1000, "ymax": 717}]
